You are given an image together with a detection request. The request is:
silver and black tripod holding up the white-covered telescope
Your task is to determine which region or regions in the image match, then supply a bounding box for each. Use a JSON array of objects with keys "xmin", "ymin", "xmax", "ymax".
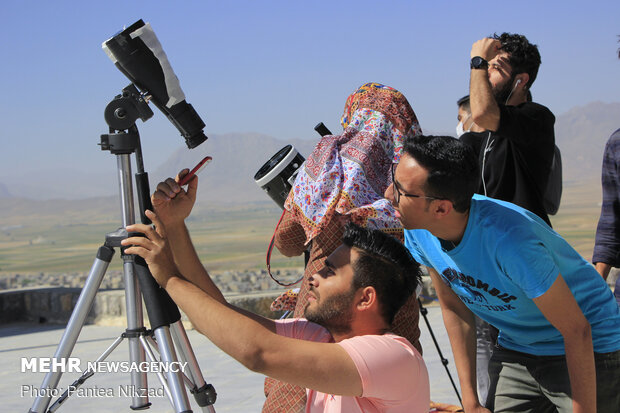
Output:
[{"xmin": 29, "ymin": 85, "xmax": 216, "ymax": 413}]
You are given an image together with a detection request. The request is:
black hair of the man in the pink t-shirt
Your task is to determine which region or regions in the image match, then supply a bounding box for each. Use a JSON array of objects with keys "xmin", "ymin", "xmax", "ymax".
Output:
[{"xmin": 342, "ymin": 222, "xmax": 422, "ymax": 324}]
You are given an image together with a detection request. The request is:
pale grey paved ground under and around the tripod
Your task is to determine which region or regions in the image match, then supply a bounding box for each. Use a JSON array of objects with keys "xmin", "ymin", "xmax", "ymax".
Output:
[{"xmin": 0, "ymin": 306, "xmax": 458, "ymax": 413}]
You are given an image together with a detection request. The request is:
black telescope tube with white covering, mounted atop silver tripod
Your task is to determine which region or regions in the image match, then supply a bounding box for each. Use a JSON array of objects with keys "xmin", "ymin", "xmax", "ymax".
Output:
[{"xmin": 102, "ymin": 20, "xmax": 207, "ymax": 149}]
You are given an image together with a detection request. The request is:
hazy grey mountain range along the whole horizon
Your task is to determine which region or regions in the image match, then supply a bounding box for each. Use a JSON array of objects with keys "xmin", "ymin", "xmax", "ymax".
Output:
[{"xmin": 0, "ymin": 102, "xmax": 620, "ymax": 209}]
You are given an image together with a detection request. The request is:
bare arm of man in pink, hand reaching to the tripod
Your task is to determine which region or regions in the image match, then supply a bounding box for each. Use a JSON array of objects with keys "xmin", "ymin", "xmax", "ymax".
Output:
[{"xmin": 123, "ymin": 212, "xmax": 362, "ymax": 396}]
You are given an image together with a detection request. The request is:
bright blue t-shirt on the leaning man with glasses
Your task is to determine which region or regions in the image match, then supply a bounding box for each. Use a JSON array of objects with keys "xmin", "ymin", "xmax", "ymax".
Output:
[{"xmin": 405, "ymin": 195, "xmax": 620, "ymax": 355}]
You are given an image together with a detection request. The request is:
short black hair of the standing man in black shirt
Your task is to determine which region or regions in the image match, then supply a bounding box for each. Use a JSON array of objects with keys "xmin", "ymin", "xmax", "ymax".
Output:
[{"xmin": 493, "ymin": 33, "xmax": 541, "ymax": 88}]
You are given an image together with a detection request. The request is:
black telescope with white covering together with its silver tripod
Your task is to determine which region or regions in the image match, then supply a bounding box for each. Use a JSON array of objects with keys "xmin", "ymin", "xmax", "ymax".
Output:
[{"xmin": 29, "ymin": 20, "xmax": 217, "ymax": 413}]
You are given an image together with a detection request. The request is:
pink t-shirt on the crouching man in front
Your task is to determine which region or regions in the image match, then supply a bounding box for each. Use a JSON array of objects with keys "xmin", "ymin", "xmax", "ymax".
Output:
[{"xmin": 277, "ymin": 319, "xmax": 430, "ymax": 413}]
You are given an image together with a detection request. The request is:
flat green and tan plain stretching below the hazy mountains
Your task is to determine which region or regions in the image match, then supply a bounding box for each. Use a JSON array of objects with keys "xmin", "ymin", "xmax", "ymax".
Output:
[{"xmin": 0, "ymin": 182, "xmax": 600, "ymax": 274}]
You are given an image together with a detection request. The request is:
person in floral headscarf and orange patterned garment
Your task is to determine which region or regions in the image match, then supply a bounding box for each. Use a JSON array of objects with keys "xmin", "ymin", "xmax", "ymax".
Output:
[{"xmin": 263, "ymin": 83, "xmax": 422, "ymax": 413}]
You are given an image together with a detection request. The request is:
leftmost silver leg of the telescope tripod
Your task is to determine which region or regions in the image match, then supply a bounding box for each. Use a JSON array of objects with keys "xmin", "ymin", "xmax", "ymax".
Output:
[{"xmin": 30, "ymin": 245, "xmax": 114, "ymax": 413}]
